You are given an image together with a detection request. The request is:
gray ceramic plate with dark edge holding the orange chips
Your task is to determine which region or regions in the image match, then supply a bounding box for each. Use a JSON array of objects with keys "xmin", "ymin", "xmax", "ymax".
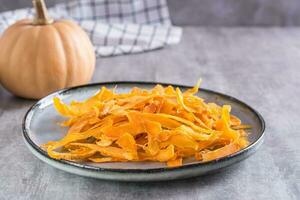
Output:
[{"xmin": 23, "ymin": 82, "xmax": 265, "ymax": 181}]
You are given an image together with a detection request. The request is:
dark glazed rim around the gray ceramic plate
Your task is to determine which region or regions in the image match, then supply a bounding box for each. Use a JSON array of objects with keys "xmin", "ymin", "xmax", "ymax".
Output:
[{"xmin": 22, "ymin": 81, "xmax": 266, "ymax": 173}]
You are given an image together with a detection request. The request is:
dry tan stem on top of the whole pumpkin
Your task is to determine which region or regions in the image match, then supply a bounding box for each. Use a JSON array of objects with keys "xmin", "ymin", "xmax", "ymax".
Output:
[{"xmin": 32, "ymin": 0, "xmax": 53, "ymax": 25}]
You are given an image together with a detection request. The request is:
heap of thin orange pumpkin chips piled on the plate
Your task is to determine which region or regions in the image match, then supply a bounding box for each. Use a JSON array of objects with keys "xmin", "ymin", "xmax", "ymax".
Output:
[{"xmin": 42, "ymin": 80, "xmax": 251, "ymax": 167}]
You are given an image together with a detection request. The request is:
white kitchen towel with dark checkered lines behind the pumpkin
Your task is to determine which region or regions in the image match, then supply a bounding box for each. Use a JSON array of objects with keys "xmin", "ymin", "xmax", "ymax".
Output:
[{"xmin": 0, "ymin": 0, "xmax": 182, "ymax": 56}]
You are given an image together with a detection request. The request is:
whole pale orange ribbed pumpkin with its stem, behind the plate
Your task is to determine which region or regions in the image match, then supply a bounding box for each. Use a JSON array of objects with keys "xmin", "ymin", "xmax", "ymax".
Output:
[{"xmin": 0, "ymin": 0, "xmax": 96, "ymax": 99}]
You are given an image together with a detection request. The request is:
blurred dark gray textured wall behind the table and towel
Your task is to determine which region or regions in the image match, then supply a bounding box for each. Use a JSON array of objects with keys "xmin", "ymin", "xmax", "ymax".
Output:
[{"xmin": 0, "ymin": 0, "xmax": 300, "ymax": 26}]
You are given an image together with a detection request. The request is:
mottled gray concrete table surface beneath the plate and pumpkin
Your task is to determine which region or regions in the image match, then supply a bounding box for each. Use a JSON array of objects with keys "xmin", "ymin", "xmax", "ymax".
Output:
[{"xmin": 0, "ymin": 27, "xmax": 300, "ymax": 200}]
